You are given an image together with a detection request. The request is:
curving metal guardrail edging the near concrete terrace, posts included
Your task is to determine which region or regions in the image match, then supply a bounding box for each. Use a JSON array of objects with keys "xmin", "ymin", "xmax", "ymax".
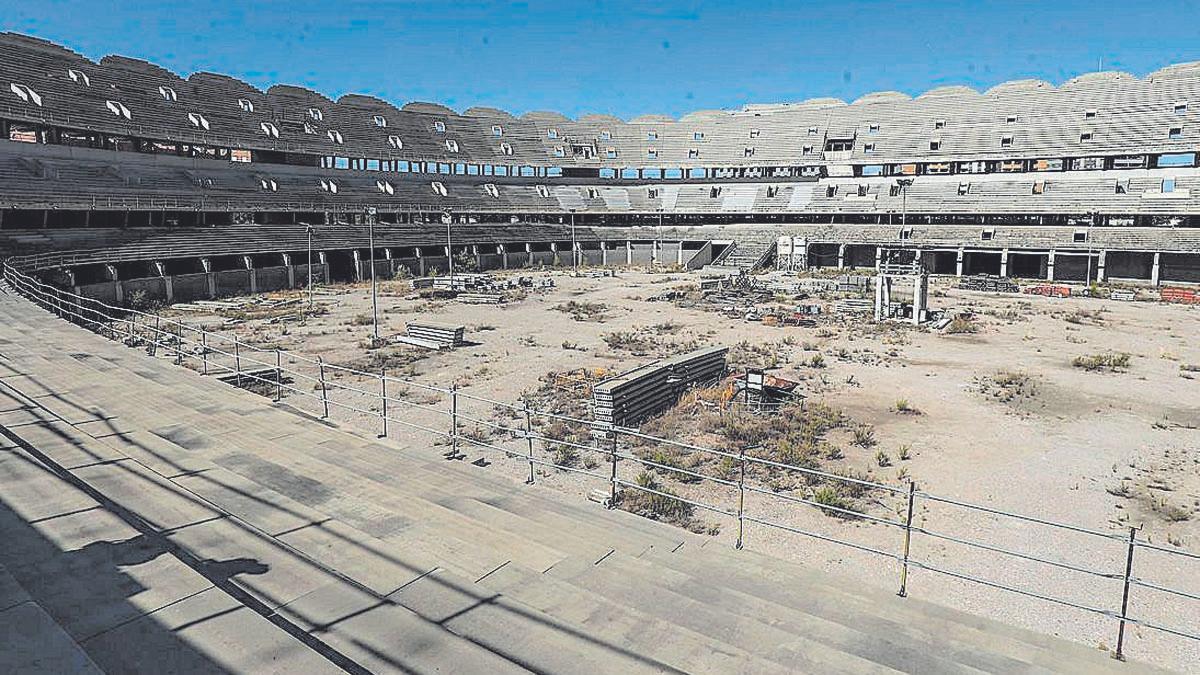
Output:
[{"xmin": 4, "ymin": 256, "xmax": 1200, "ymax": 658}]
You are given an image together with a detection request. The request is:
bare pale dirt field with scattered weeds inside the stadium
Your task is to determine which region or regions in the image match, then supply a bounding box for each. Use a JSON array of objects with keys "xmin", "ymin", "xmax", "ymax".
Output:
[{"xmin": 168, "ymin": 270, "xmax": 1200, "ymax": 670}]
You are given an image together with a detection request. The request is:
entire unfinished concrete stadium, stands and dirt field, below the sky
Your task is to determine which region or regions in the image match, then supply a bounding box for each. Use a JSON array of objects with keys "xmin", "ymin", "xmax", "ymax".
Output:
[{"xmin": 0, "ymin": 32, "xmax": 1200, "ymax": 673}]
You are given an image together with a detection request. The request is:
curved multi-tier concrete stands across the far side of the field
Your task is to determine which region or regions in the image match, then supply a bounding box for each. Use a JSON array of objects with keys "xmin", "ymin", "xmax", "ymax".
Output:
[{"xmin": 0, "ymin": 34, "xmax": 1200, "ymax": 286}]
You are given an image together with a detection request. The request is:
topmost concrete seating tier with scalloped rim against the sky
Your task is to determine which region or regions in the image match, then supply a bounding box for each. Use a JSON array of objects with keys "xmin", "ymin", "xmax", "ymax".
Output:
[{"xmin": 7, "ymin": 32, "xmax": 1200, "ymax": 168}]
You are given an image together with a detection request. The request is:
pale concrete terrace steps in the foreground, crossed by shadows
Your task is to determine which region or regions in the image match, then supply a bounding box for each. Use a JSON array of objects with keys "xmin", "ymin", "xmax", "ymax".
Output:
[{"xmin": 0, "ymin": 285, "xmax": 1142, "ymax": 673}]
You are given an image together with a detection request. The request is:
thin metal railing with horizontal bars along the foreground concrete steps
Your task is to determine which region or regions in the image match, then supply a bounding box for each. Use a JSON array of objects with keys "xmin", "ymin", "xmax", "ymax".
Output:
[{"xmin": 2, "ymin": 256, "xmax": 1200, "ymax": 656}]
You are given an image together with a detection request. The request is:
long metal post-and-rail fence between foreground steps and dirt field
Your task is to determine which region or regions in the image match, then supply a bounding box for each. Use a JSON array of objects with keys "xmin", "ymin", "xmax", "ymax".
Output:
[{"xmin": 4, "ymin": 259, "xmax": 1200, "ymax": 658}]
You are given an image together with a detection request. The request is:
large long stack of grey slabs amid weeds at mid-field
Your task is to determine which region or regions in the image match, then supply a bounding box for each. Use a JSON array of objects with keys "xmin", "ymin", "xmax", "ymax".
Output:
[{"xmin": 592, "ymin": 347, "xmax": 728, "ymax": 426}]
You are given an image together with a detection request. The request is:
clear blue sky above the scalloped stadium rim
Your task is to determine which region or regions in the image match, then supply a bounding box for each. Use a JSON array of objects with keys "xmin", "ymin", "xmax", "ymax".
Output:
[{"xmin": 0, "ymin": 0, "xmax": 1200, "ymax": 119}]
